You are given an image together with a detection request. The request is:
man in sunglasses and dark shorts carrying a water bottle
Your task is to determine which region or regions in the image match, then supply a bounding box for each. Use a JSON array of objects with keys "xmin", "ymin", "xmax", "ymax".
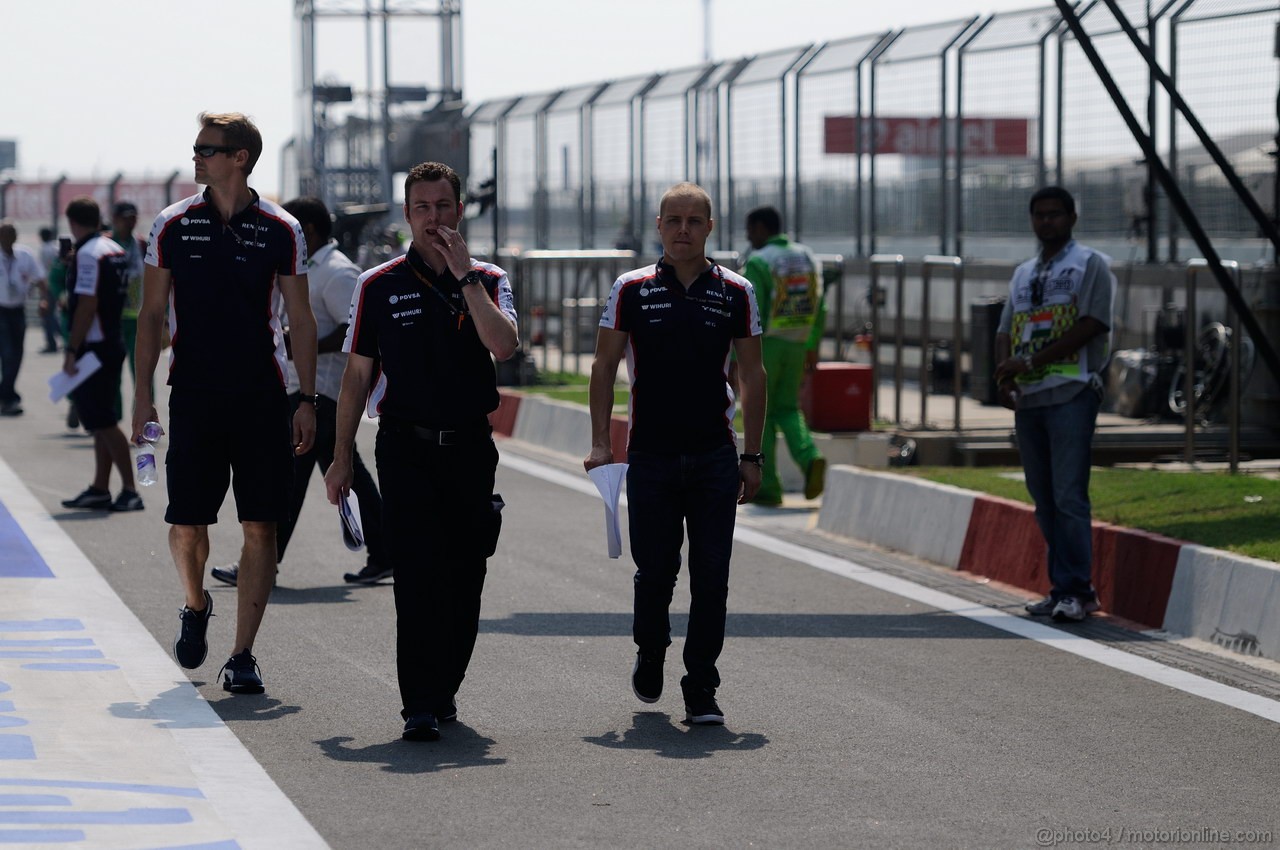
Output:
[{"xmin": 133, "ymin": 113, "xmax": 316, "ymax": 694}]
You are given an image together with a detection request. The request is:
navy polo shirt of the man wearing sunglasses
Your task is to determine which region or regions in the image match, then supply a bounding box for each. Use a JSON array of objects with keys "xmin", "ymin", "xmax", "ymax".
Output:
[{"xmin": 146, "ymin": 189, "xmax": 307, "ymax": 392}]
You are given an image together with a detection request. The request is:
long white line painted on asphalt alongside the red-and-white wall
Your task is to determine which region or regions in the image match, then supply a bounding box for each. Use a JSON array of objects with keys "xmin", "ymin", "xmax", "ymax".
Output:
[{"xmin": 499, "ymin": 453, "xmax": 1280, "ymax": 723}]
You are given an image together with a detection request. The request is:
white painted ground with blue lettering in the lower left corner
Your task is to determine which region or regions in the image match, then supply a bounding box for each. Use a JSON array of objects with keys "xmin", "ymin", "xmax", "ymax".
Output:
[{"xmin": 0, "ymin": 460, "xmax": 328, "ymax": 850}]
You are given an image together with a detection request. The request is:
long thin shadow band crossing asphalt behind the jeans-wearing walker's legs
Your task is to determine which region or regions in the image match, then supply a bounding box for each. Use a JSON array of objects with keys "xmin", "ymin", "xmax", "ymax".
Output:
[{"xmin": 480, "ymin": 612, "xmax": 1020, "ymax": 640}]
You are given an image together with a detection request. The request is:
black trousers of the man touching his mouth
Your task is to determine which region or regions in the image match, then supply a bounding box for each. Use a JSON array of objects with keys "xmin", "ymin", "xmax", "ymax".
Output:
[{"xmin": 376, "ymin": 422, "xmax": 498, "ymax": 718}]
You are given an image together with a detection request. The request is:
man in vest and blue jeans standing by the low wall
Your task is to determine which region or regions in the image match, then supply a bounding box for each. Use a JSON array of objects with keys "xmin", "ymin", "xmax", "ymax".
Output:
[{"xmin": 996, "ymin": 186, "xmax": 1116, "ymax": 622}]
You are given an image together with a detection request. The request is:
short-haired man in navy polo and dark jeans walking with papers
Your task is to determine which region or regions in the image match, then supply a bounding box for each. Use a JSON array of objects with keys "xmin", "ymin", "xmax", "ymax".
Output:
[{"xmin": 582, "ymin": 183, "xmax": 765, "ymax": 725}]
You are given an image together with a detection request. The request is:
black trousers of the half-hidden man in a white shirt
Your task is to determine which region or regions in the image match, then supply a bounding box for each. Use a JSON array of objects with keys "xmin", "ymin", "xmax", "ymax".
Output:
[{"xmin": 275, "ymin": 393, "xmax": 387, "ymax": 565}]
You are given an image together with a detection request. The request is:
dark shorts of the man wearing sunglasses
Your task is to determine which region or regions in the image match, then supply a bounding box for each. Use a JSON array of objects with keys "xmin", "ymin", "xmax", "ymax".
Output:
[{"xmin": 164, "ymin": 387, "xmax": 293, "ymax": 525}]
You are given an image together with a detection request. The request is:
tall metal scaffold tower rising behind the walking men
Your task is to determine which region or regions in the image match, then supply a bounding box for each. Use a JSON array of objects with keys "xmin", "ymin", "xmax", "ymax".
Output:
[{"xmin": 293, "ymin": 0, "xmax": 468, "ymax": 210}]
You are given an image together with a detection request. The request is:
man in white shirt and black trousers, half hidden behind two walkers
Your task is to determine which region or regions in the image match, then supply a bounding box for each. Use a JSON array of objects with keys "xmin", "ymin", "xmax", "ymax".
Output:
[{"xmin": 212, "ymin": 197, "xmax": 392, "ymax": 585}]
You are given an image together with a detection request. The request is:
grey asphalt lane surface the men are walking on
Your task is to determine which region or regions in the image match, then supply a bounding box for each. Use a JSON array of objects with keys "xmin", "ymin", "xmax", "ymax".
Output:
[{"xmin": 0, "ymin": 335, "xmax": 1280, "ymax": 850}]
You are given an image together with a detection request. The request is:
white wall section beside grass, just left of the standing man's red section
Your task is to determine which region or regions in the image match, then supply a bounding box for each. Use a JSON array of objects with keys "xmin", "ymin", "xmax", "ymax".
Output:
[{"xmin": 818, "ymin": 466, "xmax": 974, "ymax": 567}]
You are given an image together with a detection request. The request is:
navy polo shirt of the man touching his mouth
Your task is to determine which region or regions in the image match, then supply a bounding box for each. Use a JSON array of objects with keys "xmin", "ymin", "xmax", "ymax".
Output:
[{"xmin": 342, "ymin": 246, "xmax": 516, "ymax": 429}]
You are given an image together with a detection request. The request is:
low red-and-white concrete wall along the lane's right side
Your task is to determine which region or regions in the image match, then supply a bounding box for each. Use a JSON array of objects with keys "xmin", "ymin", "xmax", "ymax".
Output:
[{"xmin": 490, "ymin": 390, "xmax": 1280, "ymax": 661}]
